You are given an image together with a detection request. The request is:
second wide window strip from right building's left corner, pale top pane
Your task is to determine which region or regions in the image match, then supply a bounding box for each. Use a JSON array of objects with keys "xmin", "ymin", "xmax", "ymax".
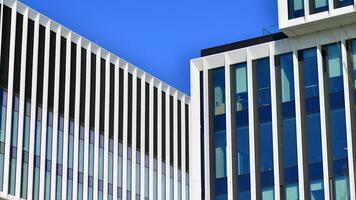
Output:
[{"xmin": 233, "ymin": 63, "xmax": 250, "ymax": 199}]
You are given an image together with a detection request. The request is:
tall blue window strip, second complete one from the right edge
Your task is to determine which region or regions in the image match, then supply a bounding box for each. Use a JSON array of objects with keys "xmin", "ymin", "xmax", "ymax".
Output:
[{"xmin": 299, "ymin": 48, "xmax": 324, "ymax": 199}]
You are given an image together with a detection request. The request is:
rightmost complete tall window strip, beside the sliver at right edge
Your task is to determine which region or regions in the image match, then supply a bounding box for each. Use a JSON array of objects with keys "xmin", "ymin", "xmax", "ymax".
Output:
[{"xmin": 323, "ymin": 43, "xmax": 350, "ymax": 199}]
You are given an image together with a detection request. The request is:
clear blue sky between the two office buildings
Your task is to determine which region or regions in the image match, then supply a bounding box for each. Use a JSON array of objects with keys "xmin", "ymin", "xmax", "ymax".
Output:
[{"xmin": 21, "ymin": 0, "xmax": 278, "ymax": 94}]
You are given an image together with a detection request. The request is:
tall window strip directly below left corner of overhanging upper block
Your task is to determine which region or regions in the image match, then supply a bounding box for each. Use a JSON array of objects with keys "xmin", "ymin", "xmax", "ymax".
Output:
[{"xmin": 276, "ymin": 53, "xmax": 299, "ymax": 200}]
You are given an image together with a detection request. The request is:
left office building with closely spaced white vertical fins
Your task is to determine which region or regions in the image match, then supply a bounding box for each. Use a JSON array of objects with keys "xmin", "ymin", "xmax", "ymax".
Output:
[{"xmin": 0, "ymin": 0, "xmax": 190, "ymax": 200}]
